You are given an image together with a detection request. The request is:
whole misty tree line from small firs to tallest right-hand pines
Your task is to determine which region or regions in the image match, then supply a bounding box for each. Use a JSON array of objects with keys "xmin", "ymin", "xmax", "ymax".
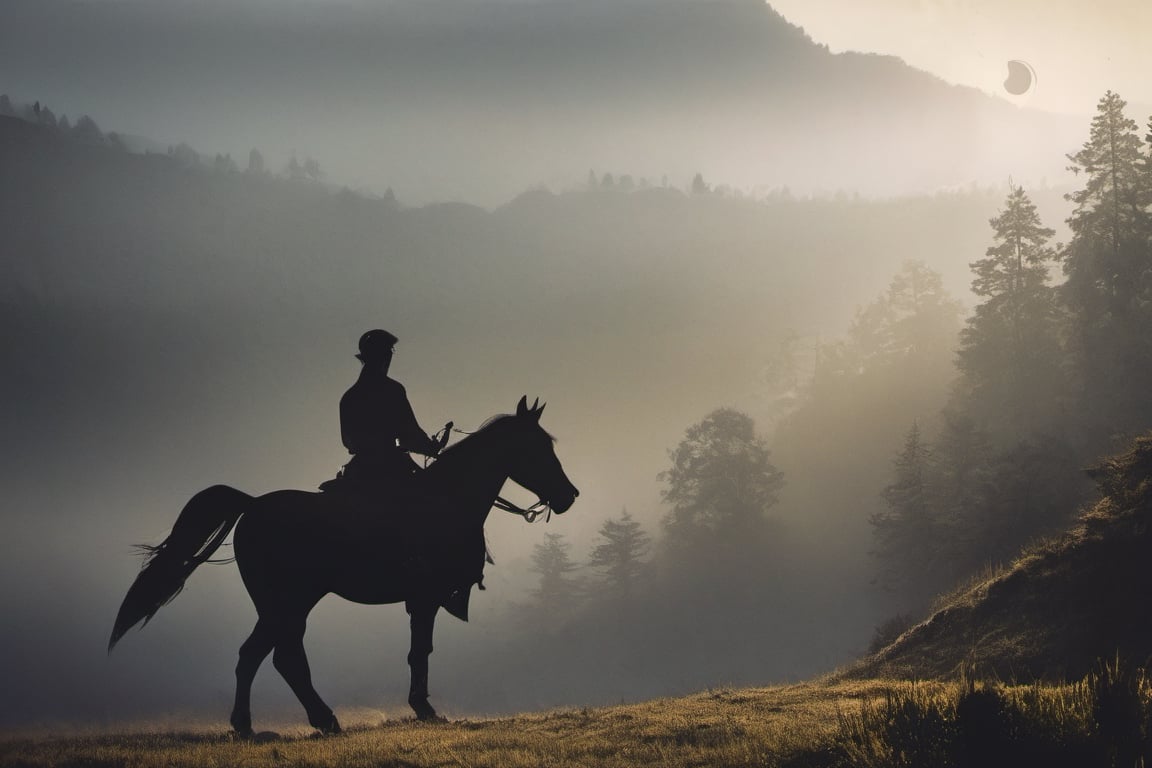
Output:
[{"xmin": 533, "ymin": 91, "xmax": 1152, "ymax": 654}]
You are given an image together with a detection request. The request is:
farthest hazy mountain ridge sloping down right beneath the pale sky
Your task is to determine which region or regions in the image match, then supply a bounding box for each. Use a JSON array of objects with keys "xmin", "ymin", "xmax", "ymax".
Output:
[{"xmin": 0, "ymin": 0, "xmax": 1085, "ymax": 204}]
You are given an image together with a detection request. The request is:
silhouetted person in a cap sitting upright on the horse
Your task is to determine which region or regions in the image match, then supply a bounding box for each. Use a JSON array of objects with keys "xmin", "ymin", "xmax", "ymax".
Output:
[{"xmin": 340, "ymin": 329, "xmax": 448, "ymax": 499}]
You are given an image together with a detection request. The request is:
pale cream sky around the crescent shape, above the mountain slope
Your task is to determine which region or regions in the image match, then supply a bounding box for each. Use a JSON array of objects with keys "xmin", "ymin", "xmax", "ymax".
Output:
[{"xmin": 771, "ymin": 0, "xmax": 1152, "ymax": 115}]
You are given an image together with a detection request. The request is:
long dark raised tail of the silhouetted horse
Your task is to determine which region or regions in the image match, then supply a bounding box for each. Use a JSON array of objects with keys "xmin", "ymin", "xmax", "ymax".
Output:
[{"xmin": 108, "ymin": 485, "xmax": 252, "ymax": 653}]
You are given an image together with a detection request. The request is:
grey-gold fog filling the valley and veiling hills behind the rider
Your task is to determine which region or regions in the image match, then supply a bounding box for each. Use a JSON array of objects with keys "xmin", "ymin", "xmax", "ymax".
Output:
[{"xmin": 0, "ymin": 0, "xmax": 1146, "ymax": 728}]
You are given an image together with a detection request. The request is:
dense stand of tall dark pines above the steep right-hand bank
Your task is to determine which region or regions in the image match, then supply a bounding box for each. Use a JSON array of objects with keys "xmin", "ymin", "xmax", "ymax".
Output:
[{"xmin": 871, "ymin": 91, "xmax": 1152, "ymax": 610}]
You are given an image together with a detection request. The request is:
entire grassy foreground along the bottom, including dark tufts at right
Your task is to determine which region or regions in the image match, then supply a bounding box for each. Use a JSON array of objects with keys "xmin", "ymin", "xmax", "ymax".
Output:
[{"xmin": 0, "ymin": 672, "xmax": 1152, "ymax": 768}]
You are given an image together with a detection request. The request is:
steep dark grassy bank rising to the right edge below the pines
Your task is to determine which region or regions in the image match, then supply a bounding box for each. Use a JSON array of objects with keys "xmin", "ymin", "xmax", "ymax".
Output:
[{"xmin": 849, "ymin": 435, "xmax": 1152, "ymax": 679}]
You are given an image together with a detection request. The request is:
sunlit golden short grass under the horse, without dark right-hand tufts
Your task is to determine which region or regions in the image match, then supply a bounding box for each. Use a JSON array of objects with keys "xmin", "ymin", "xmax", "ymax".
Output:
[{"xmin": 0, "ymin": 680, "xmax": 901, "ymax": 768}]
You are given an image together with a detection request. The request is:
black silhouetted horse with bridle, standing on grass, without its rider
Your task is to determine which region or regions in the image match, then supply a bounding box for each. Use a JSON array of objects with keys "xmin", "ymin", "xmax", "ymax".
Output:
[{"xmin": 108, "ymin": 397, "xmax": 579, "ymax": 737}]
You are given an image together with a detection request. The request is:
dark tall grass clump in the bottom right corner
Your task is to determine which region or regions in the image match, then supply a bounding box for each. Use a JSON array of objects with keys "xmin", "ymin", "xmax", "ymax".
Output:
[{"xmin": 788, "ymin": 657, "xmax": 1152, "ymax": 768}]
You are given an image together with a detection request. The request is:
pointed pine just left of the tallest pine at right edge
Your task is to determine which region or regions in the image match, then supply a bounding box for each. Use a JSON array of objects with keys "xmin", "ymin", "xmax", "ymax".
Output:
[{"xmin": 956, "ymin": 181, "xmax": 1064, "ymax": 436}]
